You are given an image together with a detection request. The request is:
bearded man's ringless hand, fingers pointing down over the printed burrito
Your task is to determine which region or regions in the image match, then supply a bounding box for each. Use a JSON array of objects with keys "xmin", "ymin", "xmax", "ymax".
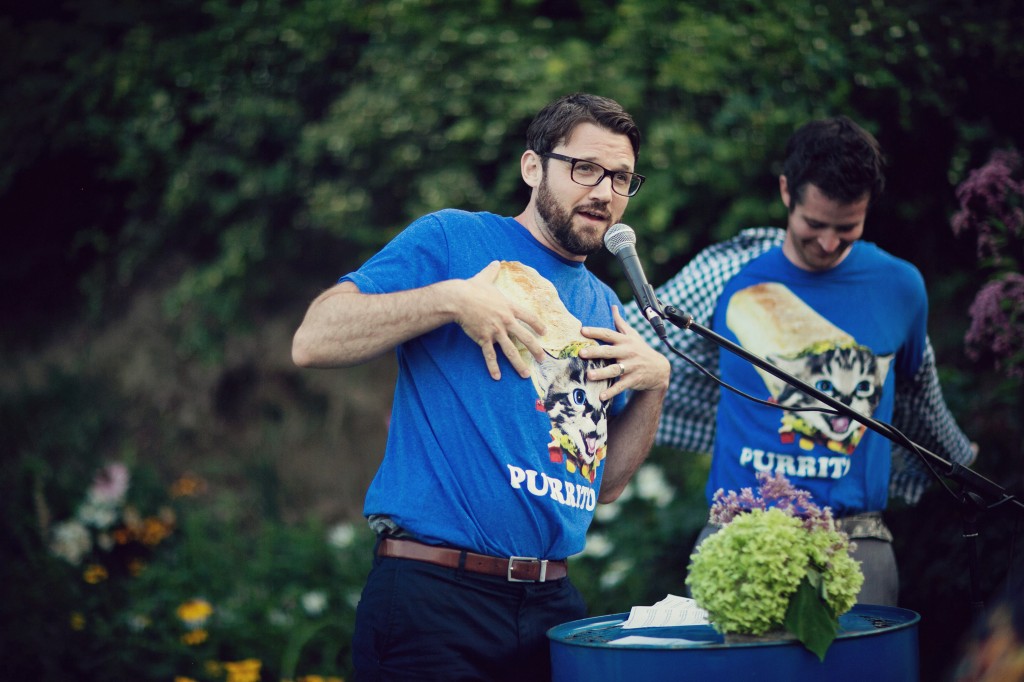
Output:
[{"xmin": 456, "ymin": 261, "xmax": 545, "ymax": 381}]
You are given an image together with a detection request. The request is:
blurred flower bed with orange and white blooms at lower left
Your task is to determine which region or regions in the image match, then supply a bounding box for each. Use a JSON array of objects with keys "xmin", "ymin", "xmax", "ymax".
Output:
[{"xmin": 3, "ymin": 446, "xmax": 372, "ymax": 682}]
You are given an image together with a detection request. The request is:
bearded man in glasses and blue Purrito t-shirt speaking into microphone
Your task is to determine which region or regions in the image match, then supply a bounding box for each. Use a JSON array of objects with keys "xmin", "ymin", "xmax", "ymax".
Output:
[{"xmin": 292, "ymin": 94, "xmax": 669, "ymax": 682}]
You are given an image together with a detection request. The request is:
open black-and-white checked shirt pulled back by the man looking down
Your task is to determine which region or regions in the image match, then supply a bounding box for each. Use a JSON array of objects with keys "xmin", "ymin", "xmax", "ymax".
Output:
[{"xmin": 625, "ymin": 227, "xmax": 975, "ymax": 504}]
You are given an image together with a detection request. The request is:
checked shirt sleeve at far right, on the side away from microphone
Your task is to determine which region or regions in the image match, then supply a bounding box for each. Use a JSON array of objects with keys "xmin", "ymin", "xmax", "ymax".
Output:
[{"xmin": 889, "ymin": 340, "xmax": 975, "ymax": 504}]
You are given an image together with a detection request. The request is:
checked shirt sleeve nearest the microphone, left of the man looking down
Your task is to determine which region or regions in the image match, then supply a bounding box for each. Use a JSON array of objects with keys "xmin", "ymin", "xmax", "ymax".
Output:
[{"xmin": 626, "ymin": 227, "xmax": 785, "ymax": 453}]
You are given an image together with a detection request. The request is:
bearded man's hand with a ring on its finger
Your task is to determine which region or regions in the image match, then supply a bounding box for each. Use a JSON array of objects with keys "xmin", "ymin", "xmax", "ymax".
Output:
[{"xmin": 580, "ymin": 306, "xmax": 672, "ymax": 400}]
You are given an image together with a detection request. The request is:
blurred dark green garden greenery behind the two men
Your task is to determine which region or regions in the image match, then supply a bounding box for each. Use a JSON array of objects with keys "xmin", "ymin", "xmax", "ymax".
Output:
[{"xmin": 0, "ymin": 0, "xmax": 1024, "ymax": 681}]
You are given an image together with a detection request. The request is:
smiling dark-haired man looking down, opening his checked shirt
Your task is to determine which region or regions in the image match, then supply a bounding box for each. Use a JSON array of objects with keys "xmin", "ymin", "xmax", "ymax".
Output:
[{"xmin": 626, "ymin": 117, "xmax": 974, "ymax": 605}]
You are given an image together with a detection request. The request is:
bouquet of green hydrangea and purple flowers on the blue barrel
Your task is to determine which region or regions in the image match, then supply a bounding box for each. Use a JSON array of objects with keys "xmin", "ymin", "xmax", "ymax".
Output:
[{"xmin": 686, "ymin": 473, "xmax": 864, "ymax": 659}]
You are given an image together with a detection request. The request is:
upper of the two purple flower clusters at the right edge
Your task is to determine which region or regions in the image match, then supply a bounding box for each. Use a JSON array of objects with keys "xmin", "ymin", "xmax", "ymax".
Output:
[{"xmin": 951, "ymin": 150, "xmax": 1024, "ymax": 264}]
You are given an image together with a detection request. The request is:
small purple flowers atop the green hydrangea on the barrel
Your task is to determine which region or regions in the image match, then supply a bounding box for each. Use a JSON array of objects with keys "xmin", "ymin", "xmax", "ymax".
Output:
[{"xmin": 710, "ymin": 471, "xmax": 833, "ymax": 530}]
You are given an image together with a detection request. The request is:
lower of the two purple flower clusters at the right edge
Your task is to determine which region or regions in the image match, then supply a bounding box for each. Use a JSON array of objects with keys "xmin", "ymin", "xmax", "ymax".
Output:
[{"xmin": 965, "ymin": 272, "xmax": 1024, "ymax": 378}]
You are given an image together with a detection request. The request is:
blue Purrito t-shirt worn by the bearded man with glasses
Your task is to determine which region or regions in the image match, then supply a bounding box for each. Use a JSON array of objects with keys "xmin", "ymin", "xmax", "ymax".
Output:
[{"xmin": 342, "ymin": 210, "xmax": 625, "ymax": 559}]
